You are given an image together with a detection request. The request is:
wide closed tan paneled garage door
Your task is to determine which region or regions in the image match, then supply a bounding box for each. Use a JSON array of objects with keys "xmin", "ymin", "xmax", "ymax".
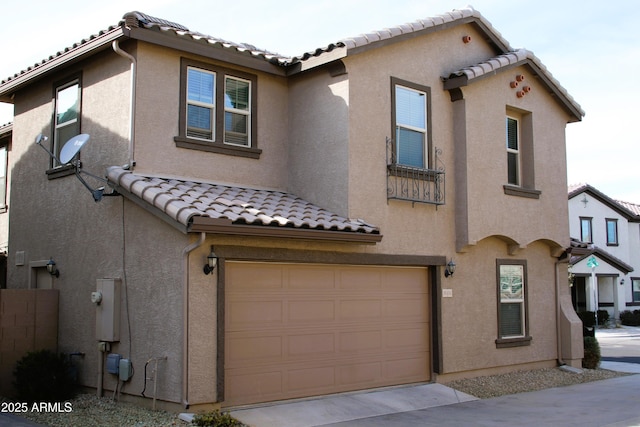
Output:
[{"xmin": 224, "ymin": 262, "xmax": 431, "ymax": 406}]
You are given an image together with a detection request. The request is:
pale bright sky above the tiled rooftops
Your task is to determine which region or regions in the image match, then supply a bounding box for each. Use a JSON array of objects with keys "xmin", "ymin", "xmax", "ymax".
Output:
[{"xmin": 0, "ymin": 0, "xmax": 640, "ymax": 204}]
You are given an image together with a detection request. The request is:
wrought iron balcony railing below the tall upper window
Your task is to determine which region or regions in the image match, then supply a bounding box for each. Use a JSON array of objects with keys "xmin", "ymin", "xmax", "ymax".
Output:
[{"xmin": 387, "ymin": 138, "xmax": 445, "ymax": 205}]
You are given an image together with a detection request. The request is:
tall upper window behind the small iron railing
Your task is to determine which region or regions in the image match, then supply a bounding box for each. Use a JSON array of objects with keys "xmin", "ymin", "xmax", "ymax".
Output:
[{"xmin": 391, "ymin": 78, "xmax": 431, "ymax": 169}]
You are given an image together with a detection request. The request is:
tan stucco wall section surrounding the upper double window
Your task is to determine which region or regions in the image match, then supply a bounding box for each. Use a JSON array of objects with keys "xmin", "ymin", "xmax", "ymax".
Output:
[{"xmin": 135, "ymin": 43, "xmax": 288, "ymax": 189}]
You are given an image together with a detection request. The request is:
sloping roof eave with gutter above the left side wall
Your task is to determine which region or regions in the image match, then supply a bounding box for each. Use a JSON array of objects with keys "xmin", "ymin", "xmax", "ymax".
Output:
[{"xmin": 0, "ymin": 27, "xmax": 126, "ymax": 103}]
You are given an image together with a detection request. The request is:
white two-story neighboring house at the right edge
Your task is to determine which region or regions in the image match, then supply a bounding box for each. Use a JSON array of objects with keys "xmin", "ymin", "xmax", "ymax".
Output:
[{"xmin": 569, "ymin": 184, "xmax": 640, "ymax": 321}]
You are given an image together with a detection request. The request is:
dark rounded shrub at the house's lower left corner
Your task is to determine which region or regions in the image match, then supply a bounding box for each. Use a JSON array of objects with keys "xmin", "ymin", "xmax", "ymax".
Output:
[{"xmin": 13, "ymin": 350, "xmax": 75, "ymax": 403}]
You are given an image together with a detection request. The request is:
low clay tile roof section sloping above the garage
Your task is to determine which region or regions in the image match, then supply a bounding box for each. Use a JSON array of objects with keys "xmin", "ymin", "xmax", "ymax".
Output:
[{"xmin": 107, "ymin": 166, "xmax": 380, "ymax": 241}]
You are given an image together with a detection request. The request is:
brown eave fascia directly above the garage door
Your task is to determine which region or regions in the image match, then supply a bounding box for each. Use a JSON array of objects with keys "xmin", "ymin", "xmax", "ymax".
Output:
[{"xmin": 188, "ymin": 216, "xmax": 382, "ymax": 244}]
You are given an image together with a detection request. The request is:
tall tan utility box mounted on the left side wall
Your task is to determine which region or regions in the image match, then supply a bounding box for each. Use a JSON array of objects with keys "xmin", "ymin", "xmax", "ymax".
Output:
[{"xmin": 91, "ymin": 279, "xmax": 122, "ymax": 342}]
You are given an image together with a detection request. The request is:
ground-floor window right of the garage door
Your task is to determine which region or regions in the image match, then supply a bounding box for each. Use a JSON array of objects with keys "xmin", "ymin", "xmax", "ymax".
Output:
[{"xmin": 496, "ymin": 259, "xmax": 531, "ymax": 347}]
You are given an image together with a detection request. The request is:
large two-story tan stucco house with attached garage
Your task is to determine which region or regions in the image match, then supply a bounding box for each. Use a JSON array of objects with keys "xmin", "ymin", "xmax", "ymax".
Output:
[{"xmin": 0, "ymin": 8, "xmax": 584, "ymax": 407}]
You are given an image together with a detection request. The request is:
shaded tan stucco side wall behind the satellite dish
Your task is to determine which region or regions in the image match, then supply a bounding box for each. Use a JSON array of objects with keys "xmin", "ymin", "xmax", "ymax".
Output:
[{"xmin": 8, "ymin": 52, "xmax": 188, "ymax": 401}]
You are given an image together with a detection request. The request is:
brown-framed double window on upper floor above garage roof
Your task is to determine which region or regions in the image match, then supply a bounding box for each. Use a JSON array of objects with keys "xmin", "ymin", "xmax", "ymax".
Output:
[{"xmin": 174, "ymin": 59, "xmax": 261, "ymax": 158}]
